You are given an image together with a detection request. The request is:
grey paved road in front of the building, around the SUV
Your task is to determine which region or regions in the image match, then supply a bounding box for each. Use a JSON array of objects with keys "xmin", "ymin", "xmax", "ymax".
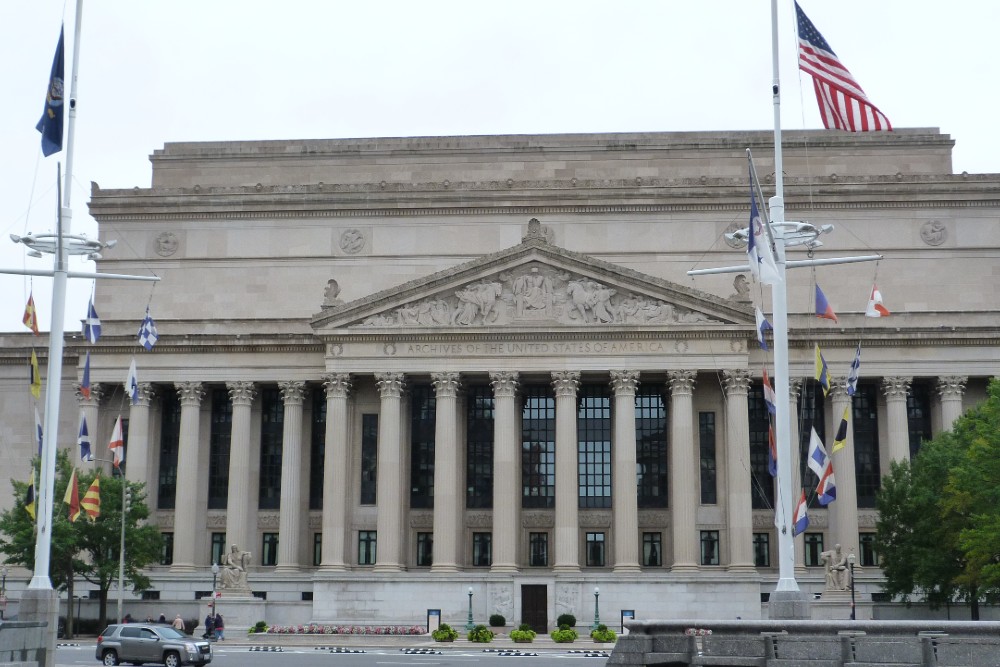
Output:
[{"xmin": 62, "ymin": 640, "xmax": 607, "ymax": 667}]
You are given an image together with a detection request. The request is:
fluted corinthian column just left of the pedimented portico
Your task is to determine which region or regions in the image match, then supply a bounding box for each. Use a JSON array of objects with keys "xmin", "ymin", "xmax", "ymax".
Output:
[{"xmin": 275, "ymin": 381, "xmax": 306, "ymax": 572}]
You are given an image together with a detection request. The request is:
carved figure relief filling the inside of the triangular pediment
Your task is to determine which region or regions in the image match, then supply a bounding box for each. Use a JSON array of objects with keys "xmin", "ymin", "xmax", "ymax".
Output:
[{"xmin": 361, "ymin": 265, "xmax": 718, "ymax": 328}]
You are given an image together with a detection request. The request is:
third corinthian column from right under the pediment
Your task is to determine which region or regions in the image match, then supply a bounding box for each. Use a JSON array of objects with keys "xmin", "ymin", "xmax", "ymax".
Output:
[{"xmin": 611, "ymin": 371, "xmax": 639, "ymax": 572}]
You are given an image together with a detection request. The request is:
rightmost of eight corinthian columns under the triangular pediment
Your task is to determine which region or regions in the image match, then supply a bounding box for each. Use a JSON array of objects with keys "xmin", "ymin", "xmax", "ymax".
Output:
[{"xmin": 722, "ymin": 368, "xmax": 754, "ymax": 571}]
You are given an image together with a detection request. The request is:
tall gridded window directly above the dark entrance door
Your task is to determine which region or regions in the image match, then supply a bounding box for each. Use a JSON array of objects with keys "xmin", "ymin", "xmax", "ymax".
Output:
[{"xmin": 521, "ymin": 385, "xmax": 556, "ymax": 508}]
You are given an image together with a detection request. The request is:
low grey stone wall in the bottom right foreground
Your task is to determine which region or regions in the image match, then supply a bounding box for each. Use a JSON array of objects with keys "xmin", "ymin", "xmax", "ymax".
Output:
[{"xmin": 608, "ymin": 620, "xmax": 1000, "ymax": 667}]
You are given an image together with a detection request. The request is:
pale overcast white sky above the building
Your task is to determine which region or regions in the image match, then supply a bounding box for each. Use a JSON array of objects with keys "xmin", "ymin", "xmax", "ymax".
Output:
[{"xmin": 0, "ymin": 0, "xmax": 1000, "ymax": 331}]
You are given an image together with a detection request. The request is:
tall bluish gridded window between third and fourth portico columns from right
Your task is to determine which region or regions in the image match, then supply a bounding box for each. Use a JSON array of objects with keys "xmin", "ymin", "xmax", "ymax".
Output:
[{"xmin": 576, "ymin": 384, "xmax": 612, "ymax": 507}]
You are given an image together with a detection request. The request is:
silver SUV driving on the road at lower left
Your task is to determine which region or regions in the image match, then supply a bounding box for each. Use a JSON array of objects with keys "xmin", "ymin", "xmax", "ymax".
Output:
[{"xmin": 96, "ymin": 623, "xmax": 212, "ymax": 667}]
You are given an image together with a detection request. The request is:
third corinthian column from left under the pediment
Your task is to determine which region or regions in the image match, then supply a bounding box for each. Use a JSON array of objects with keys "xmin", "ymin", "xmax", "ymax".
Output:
[{"xmin": 431, "ymin": 372, "xmax": 465, "ymax": 572}]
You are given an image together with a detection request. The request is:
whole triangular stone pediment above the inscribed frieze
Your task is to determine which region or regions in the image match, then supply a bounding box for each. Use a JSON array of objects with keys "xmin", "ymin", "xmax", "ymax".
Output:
[{"xmin": 311, "ymin": 222, "xmax": 754, "ymax": 333}]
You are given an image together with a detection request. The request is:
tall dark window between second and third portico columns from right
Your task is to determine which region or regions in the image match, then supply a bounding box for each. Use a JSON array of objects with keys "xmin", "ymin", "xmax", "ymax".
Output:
[{"xmin": 635, "ymin": 387, "xmax": 668, "ymax": 507}]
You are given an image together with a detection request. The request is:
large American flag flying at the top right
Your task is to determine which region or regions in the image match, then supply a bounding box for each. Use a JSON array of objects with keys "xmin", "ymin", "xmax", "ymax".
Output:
[{"xmin": 795, "ymin": 2, "xmax": 892, "ymax": 132}]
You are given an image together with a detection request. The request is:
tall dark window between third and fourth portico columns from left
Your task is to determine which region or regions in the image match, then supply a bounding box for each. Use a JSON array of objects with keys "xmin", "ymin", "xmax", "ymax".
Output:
[{"xmin": 465, "ymin": 385, "xmax": 493, "ymax": 509}]
